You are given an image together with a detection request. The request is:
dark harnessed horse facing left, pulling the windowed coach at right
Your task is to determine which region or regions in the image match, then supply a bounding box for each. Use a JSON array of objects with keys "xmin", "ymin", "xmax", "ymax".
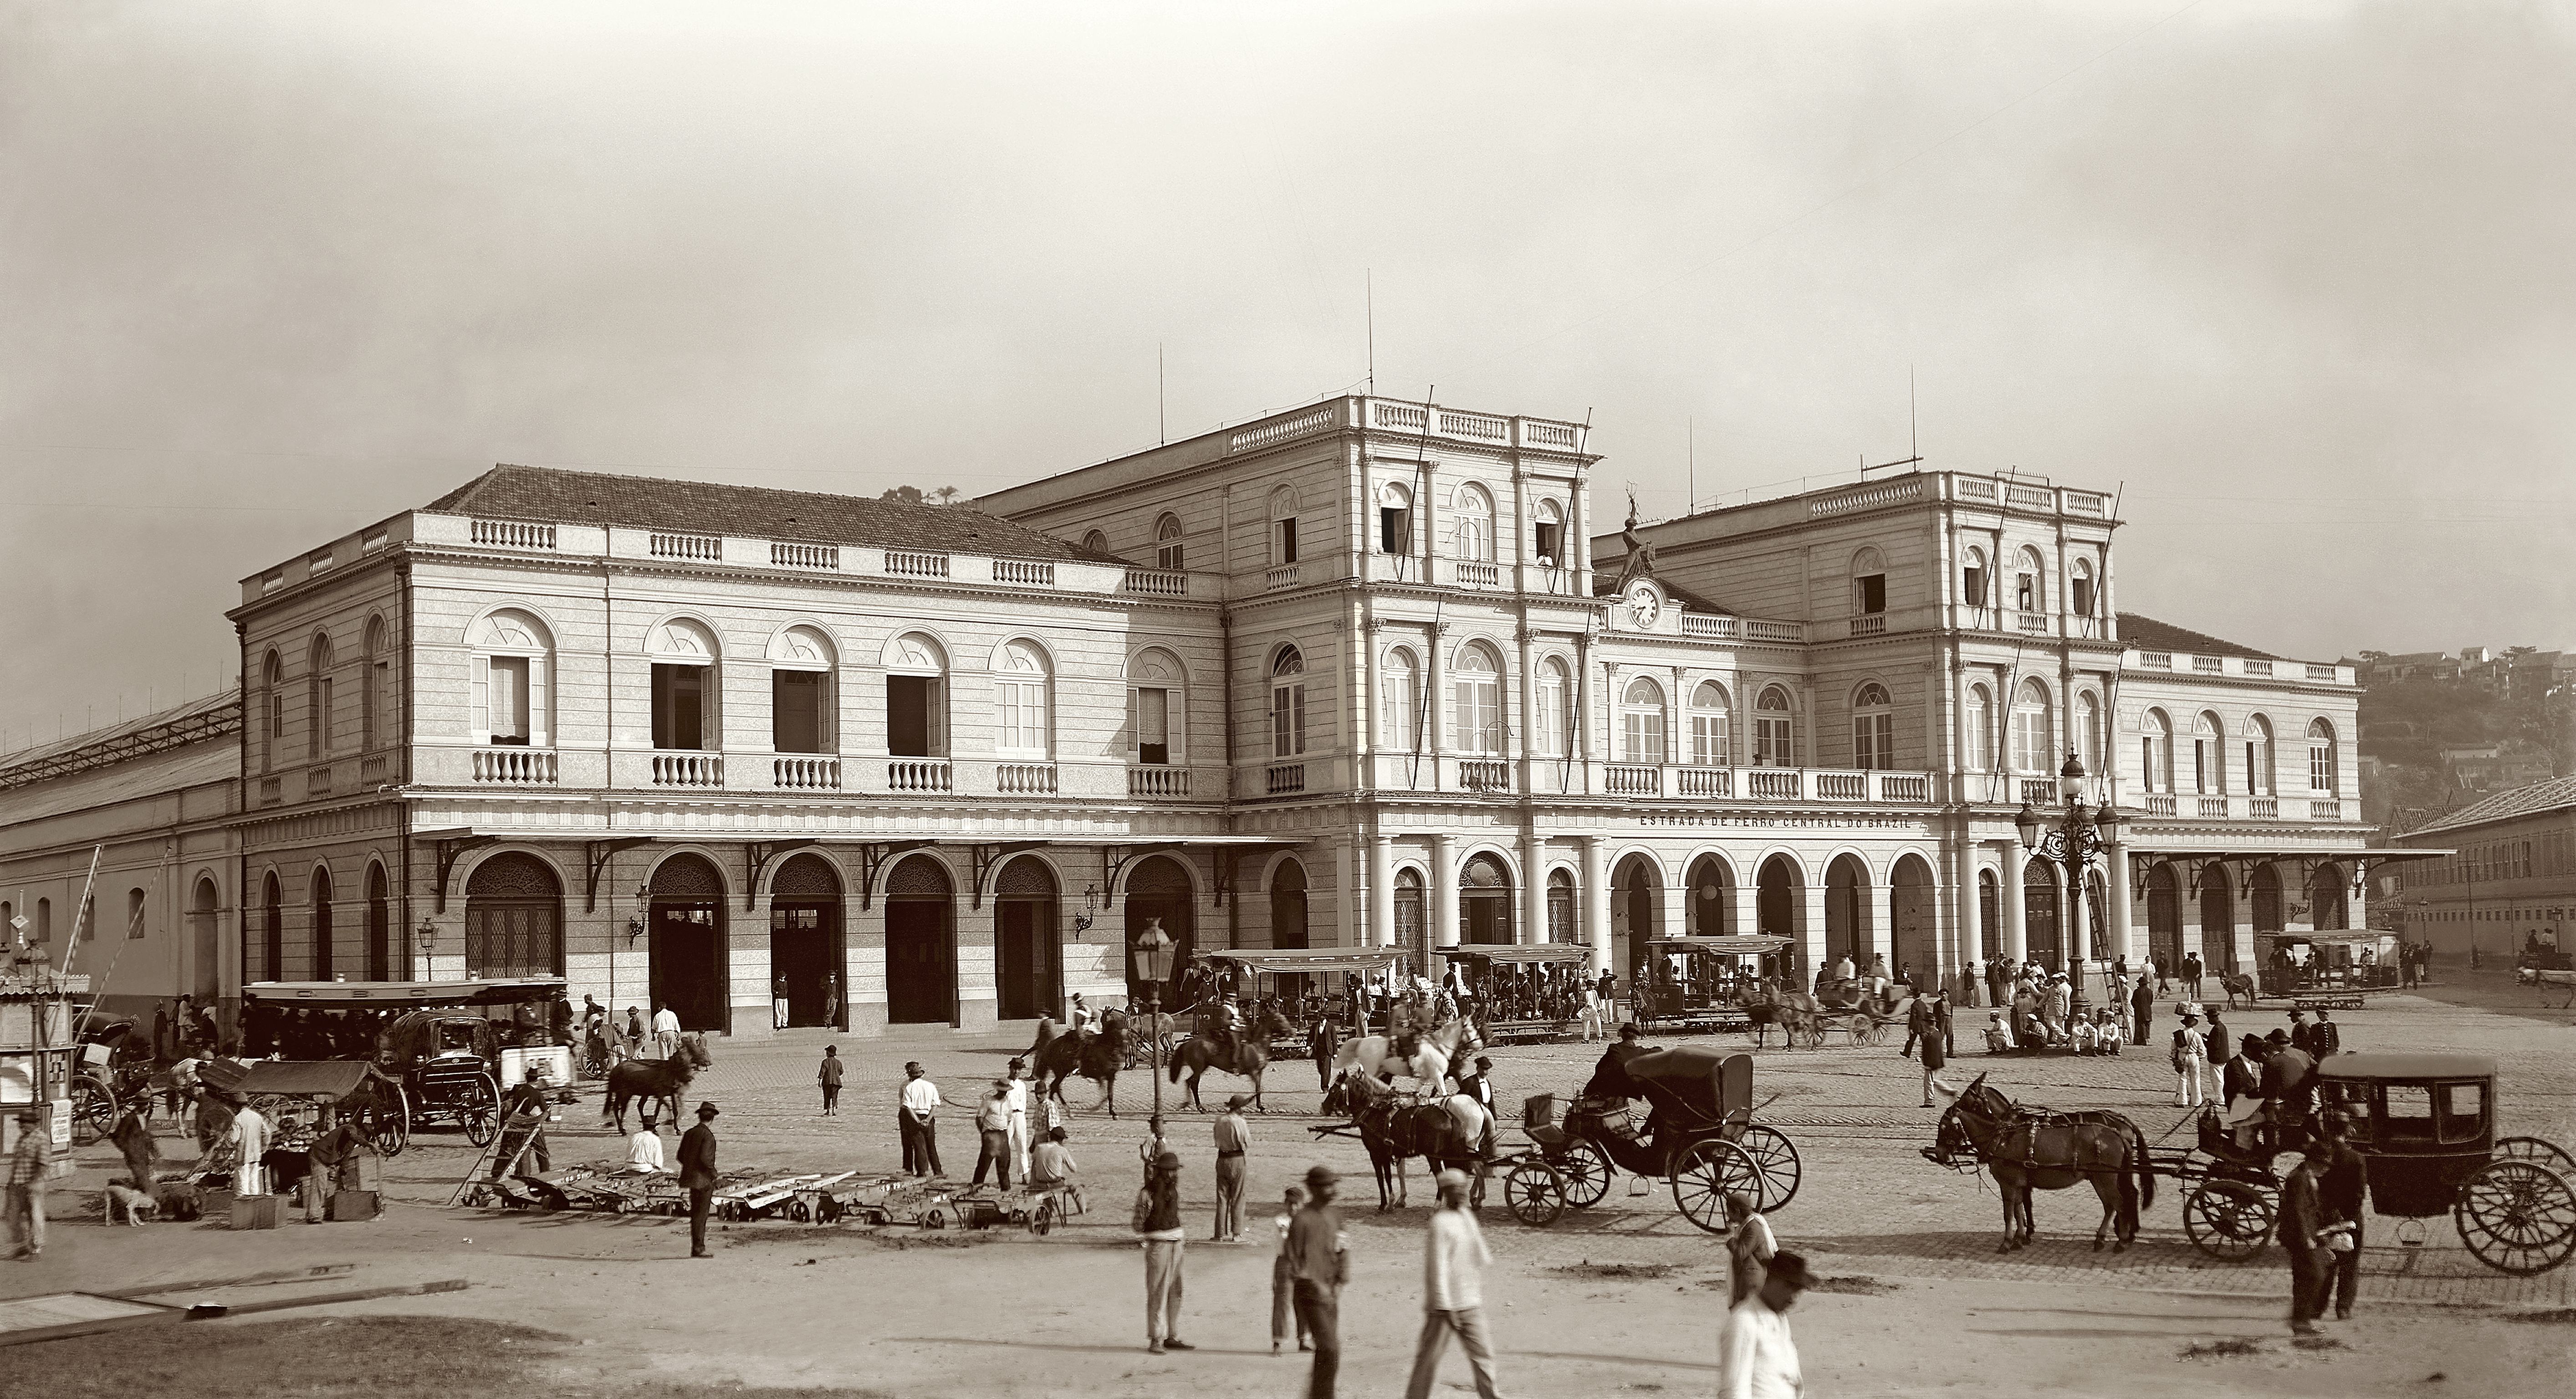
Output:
[{"xmin": 1935, "ymin": 1074, "xmax": 2156, "ymax": 1252}]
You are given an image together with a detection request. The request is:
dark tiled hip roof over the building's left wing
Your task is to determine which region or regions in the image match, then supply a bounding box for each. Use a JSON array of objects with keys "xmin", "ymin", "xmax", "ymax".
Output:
[{"xmin": 423, "ymin": 464, "xmax": 1126, "ymax": 564}]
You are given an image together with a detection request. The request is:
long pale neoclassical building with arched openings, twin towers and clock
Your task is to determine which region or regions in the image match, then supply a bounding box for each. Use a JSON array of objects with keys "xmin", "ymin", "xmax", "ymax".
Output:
[{"xmin": 232, "ymin": 397, "xmax": 2370, "ymax": 1033}]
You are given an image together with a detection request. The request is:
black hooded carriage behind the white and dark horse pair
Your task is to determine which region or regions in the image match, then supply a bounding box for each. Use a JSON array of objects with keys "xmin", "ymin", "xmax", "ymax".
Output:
[{"xmin": 1497, "ymin": 1044, "xmax": 1803, "ymax": 1234}]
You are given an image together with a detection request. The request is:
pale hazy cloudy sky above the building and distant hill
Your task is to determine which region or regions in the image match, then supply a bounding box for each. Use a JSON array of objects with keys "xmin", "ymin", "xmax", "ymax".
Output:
[{"xmin": 0, "ymin": 0, "xmax": 2576, "ymax": 750}]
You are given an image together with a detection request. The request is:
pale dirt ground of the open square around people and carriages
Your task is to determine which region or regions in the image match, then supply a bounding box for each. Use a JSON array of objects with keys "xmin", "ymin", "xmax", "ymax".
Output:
[{"xmin": 0, "ymin": 969, "xmax": 2576, "ymax": 1399}]
